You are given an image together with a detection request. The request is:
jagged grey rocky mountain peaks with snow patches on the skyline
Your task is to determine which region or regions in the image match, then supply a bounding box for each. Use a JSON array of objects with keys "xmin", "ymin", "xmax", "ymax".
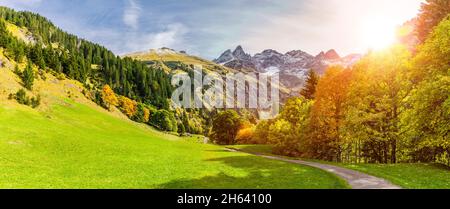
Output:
[{"xmin": 214, "ymin": 46, "xmax": 361, "ymax": 94}]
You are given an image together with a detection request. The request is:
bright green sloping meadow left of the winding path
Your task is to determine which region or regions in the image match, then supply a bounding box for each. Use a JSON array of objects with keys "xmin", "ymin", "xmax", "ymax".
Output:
[{"xmin": 0, "ymin": 101, "xmax": 348, "ymax": 188}]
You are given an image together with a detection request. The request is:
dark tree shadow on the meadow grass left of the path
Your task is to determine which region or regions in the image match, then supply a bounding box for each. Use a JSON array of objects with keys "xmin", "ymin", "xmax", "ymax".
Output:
[{"xmin": 158, "ymin": 153, "xmax": 346, "ymax": 189}]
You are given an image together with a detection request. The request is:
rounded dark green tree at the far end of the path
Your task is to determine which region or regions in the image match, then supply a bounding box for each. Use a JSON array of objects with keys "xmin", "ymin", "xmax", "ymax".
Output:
[{"xmin": 211, "ymin": 110, "xmax": 242, "ymax": 145}]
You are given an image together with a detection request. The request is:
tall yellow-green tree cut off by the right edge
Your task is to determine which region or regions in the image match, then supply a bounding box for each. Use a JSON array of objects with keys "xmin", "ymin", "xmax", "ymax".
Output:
[{"xmin": 402, "ymin": 17, "xmax": 450, "ymax": 165}]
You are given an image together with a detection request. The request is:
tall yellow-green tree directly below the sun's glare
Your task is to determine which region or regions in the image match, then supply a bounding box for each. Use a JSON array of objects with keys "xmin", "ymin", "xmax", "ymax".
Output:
[{"xmin": 341, "ymin": 46, "xmax": 411, "ymax": 163}]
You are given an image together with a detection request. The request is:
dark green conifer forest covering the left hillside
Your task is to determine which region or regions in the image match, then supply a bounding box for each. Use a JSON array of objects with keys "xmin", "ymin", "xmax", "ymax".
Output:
[{"xmin": 0, "ymin": 7, "xmax": 172, "ymax": 109}]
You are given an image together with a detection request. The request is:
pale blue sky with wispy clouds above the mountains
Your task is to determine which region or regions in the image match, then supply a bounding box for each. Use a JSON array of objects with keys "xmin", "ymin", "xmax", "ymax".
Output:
[{"xmin": 0, "ymin": 0, "xmax": 422, "ymax": 59}]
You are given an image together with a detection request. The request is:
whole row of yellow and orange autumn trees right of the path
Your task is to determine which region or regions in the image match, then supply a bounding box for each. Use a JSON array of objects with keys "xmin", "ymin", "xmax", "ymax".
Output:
[{"xmin": 253, "ymin": 10, "xmax": 450, "ymax": 165}]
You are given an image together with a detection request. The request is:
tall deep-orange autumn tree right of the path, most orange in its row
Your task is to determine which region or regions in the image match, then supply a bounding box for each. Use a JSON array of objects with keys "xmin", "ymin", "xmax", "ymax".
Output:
[{"xmin": 307, "ymin": 66, "xmax": 352, "ymax": 160}]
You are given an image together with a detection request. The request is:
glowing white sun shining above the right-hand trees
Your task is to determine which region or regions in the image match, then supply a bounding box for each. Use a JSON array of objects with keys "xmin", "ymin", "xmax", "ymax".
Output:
[{"xmin": 362, "ymin": 17, "xmax": 397, "ymax": 50}]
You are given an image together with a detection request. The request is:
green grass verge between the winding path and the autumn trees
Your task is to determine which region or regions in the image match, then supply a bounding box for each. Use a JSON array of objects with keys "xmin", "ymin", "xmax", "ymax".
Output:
[{"xmin": 231, "ymin": 145, "xmax": 450, "ymax": 189}]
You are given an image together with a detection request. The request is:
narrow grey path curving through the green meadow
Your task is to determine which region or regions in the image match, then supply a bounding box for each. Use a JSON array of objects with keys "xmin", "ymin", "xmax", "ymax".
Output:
[{"xmin": 226, "ymin": 148, "xmax": 401, "ymax": 189}]
